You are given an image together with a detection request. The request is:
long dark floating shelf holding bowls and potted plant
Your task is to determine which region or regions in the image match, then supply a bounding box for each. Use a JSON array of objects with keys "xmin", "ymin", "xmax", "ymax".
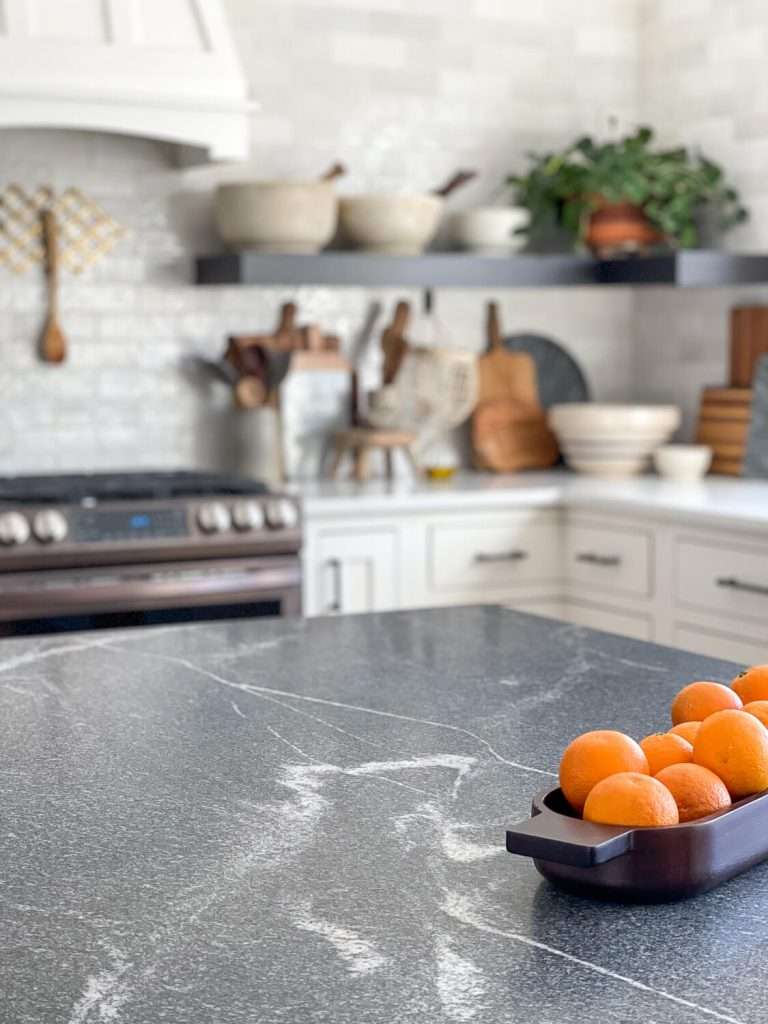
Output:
[{"xmin": 196, "ymin": 249, "xmax": 768, "ymax": 288}]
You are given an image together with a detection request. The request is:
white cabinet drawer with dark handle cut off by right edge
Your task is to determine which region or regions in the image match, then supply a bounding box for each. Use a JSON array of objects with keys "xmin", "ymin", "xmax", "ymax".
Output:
[{"xmin": 675, "ymin": 539, "xmax": 768, "ymax": 632}]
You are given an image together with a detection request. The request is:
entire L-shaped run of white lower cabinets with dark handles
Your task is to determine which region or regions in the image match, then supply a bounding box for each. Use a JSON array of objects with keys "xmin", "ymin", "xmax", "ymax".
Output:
[{"xmin": 304, "ymin": 493, "xmax": 768, "ymax": 664}]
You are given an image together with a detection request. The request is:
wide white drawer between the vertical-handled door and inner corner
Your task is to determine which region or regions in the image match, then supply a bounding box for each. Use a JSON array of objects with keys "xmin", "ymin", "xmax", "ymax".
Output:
[{"xmin": 427, "ymin": 516, "xmax": 560, "ymax": 591}]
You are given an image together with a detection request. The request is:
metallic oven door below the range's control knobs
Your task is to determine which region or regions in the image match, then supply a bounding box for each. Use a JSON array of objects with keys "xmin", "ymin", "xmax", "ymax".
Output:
[{"xmin": 0, "ymin": 556, "xmax": 301, "ymax": 636}]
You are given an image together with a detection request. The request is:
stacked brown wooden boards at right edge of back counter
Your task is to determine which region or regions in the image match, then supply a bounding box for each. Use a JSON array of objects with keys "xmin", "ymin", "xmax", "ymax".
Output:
[{"xmin": 696, "ymin": 306, "xmax": 768, "ymax": 476}]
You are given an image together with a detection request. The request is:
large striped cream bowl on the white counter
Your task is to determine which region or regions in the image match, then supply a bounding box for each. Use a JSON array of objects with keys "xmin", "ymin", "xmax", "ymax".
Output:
[{"xmin": 549, "ymin": 402, "xmax": 681, "ymax": 476}]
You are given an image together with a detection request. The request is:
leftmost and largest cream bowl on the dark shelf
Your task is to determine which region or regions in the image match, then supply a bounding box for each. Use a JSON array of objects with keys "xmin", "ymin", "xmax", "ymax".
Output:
[{"xmin": 215, "ymin": 181, "xmax": 338, "ymax": 253}]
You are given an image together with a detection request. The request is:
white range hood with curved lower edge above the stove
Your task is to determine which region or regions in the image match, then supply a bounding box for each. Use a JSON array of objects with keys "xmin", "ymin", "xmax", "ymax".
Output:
[{"xmin": 0, "ymin": 0, "xmax": 253, "ymax": 163}]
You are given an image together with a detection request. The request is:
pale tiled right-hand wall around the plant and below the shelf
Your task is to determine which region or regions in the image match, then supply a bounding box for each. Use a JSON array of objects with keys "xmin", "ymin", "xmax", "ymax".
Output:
[{"xmin": 634, "ymin": 0, "xmax": 768, "ymax": 436}]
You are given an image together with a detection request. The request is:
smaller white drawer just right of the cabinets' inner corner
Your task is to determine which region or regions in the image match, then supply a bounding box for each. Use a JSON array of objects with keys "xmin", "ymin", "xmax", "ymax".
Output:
[{"xmin": 565, "ymin": 522, "xmax": 653, "ymax": 597}]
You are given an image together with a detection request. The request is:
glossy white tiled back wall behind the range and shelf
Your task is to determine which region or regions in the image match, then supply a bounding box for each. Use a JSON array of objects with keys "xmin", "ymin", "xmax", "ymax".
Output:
[{"xmin": 0, "ymin": 0, "xmax": 696, "ymax": 472}]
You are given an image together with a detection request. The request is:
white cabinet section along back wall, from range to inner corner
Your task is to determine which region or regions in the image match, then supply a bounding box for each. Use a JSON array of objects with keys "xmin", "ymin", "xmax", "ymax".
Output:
[{"xmin": 304, "ymin": 508, "xmax": 562, "ymax": 615}]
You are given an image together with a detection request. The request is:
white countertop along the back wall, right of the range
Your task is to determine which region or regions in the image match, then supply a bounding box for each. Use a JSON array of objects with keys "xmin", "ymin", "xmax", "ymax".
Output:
[{"xmin": 296, "ymin": 470, "xmax": 768, "ymax": 529}]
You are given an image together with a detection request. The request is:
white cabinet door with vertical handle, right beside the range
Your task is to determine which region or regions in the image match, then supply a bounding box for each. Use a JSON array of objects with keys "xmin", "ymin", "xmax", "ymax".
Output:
[{"xmin": 304, "ymin": 527, "xmax": 399, "ymax": 615}]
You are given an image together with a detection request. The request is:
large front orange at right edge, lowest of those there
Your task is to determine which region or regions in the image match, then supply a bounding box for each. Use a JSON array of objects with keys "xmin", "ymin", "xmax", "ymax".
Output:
[{"xmin": 693, "ymin": 711, "xmax": 768, "ymax": 800}]
